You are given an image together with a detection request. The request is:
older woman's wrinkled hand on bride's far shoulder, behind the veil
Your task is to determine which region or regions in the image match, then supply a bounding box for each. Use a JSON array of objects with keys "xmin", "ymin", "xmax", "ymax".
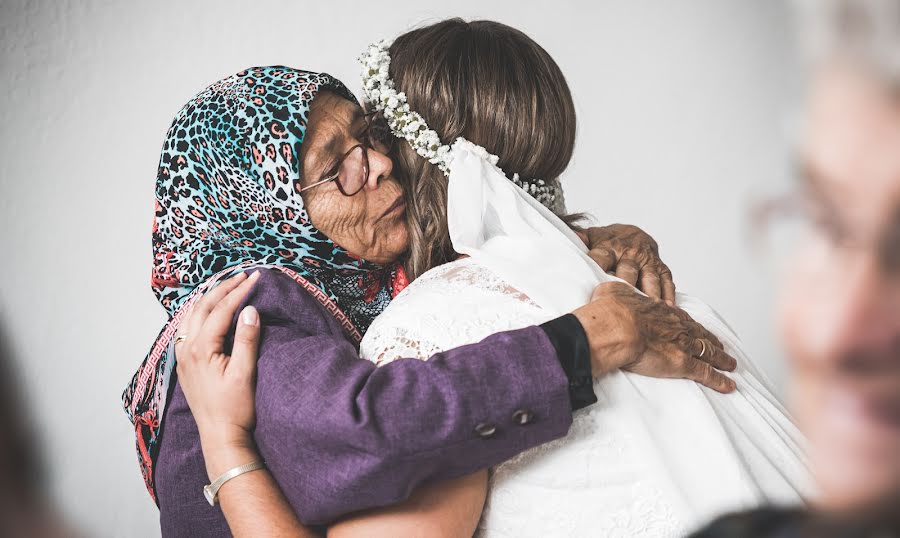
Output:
[{"xmin": 579, "ymin": 224, "xmax": 675, "ymax": 306}]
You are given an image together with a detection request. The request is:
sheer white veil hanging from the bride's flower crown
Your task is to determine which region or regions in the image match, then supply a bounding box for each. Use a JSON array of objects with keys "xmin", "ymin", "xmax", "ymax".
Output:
[{"xmin": 447, "ymin": 139, "xmax": 811, "ymax": 524}]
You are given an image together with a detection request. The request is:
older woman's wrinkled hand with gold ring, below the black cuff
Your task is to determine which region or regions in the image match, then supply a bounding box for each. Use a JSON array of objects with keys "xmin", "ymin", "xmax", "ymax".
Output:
[{"xmin": 573, "ymin": 282, "xmax": 737, "ymax": 393}]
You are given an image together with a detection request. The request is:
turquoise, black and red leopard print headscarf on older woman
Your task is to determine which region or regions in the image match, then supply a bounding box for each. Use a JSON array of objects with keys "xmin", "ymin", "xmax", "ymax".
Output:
[{"xmin": 123, "ymin": 66, "xmax": 405, "ymax": 499}]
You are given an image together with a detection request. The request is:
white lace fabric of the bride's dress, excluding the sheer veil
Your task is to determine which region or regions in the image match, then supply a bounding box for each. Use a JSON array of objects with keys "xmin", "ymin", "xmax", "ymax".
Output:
[{"xmin": 360, "ymin": 258, "xmax": 684, "ymax": 537}]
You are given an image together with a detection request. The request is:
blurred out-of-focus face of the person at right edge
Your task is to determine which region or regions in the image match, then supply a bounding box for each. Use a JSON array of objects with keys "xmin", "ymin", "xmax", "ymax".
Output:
[{"xmin": 780, "ymin": 68, "xmax": 900, "ymax": 508}]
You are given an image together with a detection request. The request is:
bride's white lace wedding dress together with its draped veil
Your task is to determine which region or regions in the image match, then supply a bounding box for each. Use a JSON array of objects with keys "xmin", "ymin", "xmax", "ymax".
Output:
[{"xmin": 360, "ymin": 141, "xmax": 812, "ymax": 538}]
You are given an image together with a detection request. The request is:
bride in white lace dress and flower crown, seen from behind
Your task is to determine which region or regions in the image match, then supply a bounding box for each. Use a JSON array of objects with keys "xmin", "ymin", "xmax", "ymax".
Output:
[{"xmin": 181, "ymin": 20, "xmax": 810, "ymax": 536}]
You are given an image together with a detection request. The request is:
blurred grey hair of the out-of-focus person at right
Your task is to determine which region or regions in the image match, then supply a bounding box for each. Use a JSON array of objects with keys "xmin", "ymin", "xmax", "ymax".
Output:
[{"xmin": 794, "ymin": 0, "xmax": 900, "ymax": 85}]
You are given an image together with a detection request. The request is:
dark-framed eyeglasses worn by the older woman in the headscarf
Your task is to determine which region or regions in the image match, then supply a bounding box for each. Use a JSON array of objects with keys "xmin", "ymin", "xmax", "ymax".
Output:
[{"xmin": 300, "ymin": 113, "xmax": 394, "ymax": 196}]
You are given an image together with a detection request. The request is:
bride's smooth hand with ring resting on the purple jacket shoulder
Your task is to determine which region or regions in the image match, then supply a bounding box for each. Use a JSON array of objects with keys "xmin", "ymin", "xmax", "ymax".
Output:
[{"xmin": 175, "ymin": 272, "xmax": 260, "ymax": 460}]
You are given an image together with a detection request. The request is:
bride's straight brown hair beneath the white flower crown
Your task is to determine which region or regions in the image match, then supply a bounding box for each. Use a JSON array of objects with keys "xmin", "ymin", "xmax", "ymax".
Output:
[{"xmin": 390, "ymin": 19, "xmax": 575, "ymax": 279}]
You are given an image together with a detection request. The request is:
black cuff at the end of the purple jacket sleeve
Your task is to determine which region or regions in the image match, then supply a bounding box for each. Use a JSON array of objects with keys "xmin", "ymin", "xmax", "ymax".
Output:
[{"xmin": 541, "ymin": 314, "xmax": 597, "ymax": 411}]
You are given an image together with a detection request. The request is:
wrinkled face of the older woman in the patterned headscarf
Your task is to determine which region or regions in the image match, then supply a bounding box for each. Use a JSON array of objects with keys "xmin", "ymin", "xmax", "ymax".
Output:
[{"xmin": 301, "ymin": 91, "xmax": 408, "ymax": 264}]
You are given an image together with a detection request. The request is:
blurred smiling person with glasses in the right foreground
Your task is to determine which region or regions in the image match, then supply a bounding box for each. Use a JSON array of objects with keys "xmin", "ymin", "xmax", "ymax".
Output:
[{"xmin": 697, "ymin": 0, "xmax": 900, "ymax": 537}]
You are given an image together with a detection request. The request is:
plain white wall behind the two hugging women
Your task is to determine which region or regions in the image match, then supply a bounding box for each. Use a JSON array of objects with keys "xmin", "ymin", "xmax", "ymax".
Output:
[{"xmin": 0, "ymin": 0, "xmax": 793, "ymax": 537}]
